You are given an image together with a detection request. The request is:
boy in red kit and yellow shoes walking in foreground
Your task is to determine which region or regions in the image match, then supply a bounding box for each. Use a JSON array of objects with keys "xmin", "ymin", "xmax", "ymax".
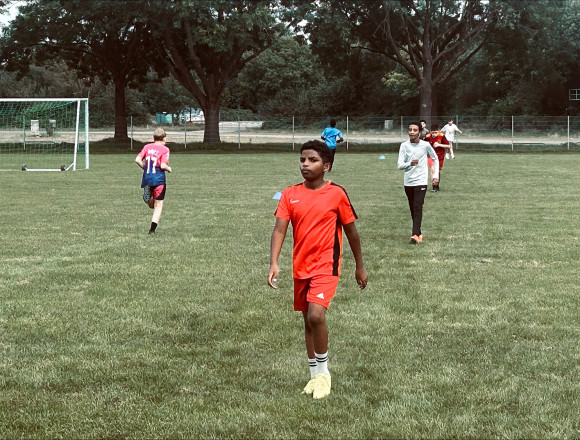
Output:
[{"xmin": 268, "ymin": 141, "xmax": 368, "ymax": 399}]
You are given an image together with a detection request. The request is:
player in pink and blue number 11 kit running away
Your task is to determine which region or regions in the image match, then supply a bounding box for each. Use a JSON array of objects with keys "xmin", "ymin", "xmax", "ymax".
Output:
[{"xmin": 135, "ymin": 128, "xmax": 171, "ymax": 234}]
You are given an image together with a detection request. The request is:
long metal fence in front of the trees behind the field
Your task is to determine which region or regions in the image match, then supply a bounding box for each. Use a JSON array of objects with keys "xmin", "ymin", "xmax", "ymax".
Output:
[{"xmin": 113, "ymin": 115, "xmax": 580, "ymax": 151}]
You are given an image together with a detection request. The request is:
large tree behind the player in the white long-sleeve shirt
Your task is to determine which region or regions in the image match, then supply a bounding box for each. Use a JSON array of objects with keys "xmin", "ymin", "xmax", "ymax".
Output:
[{"xmin": 327, "ymin": 0, "xmax": 493, "ymax": 117}]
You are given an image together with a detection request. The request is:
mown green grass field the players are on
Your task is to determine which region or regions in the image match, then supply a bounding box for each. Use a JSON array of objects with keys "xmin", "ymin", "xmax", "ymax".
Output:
[{"xmin": 0, "ymin": 153, "xmax": 580, "ymax": 439}]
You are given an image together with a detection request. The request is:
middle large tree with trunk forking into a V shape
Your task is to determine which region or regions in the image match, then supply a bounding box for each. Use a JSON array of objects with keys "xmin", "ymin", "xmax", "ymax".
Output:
[{"xmin": 151, "ymin": 0, "xmax": 308, "ymax": 142}]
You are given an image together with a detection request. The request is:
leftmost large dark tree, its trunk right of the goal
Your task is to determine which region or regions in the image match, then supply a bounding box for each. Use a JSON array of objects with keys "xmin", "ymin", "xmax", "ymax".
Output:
[{"xmin": 0, "ymin": 0, "xmax": 153, "ymax": 139}]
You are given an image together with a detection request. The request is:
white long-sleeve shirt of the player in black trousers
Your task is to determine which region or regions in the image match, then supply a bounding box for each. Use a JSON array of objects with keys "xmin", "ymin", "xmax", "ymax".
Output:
[{"xmin": 397, "ymin": 141, "xmax": 439, "ymax": 186}]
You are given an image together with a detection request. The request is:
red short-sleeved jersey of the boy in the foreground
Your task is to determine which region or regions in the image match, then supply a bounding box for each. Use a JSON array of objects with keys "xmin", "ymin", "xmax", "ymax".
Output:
[{"xmin": 275, "ymin": 181, "xmax": 357, "ymax": 279}]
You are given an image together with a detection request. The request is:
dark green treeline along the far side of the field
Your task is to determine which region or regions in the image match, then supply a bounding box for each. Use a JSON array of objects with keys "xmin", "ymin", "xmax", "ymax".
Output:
[{"xmin": 0, "ymin": 0, "xmax": 580, "ymax": 140}]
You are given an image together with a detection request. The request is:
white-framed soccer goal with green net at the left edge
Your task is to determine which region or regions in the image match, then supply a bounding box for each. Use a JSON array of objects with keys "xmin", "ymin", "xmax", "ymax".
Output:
[{"xmin": 0, "ymin": 98, "xmax": 89, "ymax": 171}]
